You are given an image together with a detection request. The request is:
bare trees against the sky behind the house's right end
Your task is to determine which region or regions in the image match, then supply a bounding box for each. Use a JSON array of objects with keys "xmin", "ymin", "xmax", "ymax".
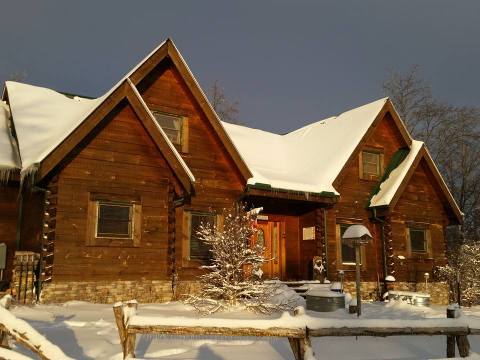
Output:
[{"xmin": 383, "ymin": 66, "xmax": 480, "ymax": 240}]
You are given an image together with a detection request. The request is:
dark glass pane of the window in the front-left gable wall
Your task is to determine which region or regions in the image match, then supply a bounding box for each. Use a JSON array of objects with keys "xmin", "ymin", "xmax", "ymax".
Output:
[{"xmin": 97, "ymin": 202, "xmax": 132, "ymax": 238}]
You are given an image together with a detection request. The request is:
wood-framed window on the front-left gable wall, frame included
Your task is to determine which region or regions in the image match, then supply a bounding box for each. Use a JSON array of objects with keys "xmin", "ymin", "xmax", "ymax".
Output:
[{"xmin": 86, "ymin": 193, "xmax": 142, "ymax": 246}]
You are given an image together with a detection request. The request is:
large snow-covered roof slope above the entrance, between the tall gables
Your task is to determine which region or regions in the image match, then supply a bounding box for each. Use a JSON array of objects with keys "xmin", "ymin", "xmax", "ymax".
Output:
[{"xmin": 223, "ymin": 98, "xmax": 388, "ymax": 195}]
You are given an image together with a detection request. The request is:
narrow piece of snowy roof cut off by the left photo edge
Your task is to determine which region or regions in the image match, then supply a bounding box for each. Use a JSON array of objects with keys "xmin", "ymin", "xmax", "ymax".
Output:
[{"xmin": 0, "ymin": 101, "xmax": 21, "ymax": 179}]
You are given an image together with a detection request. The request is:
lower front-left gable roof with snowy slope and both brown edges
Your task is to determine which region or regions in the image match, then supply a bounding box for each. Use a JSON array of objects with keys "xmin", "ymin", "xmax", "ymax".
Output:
[{"xmin": 5, "ymin": 78, "xmax": 195, "ymax": 192}]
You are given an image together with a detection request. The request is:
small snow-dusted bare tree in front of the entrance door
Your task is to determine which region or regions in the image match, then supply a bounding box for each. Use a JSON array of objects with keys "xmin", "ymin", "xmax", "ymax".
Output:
[{"xmin": 186, "ymin": 205, "xmax": 294, "ymax": 314}]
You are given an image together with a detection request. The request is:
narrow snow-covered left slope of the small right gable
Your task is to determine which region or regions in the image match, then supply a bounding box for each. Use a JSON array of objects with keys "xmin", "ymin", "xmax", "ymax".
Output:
[{"xmin": 370, "ymin": 140, "xmax": 423, "ymax": 207}]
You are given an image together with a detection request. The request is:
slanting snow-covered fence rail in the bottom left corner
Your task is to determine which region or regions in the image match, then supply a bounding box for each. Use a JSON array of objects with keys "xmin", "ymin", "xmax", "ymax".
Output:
[{"xmin": 0, "ymin": 295, "xmax": 72, "ymax": 360}]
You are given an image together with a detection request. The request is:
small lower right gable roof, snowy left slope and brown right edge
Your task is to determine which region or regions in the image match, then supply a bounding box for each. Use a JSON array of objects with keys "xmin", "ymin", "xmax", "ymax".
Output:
[{"xmin": 370, "ymin": 140, "xmax": 463, "ymax": 224}]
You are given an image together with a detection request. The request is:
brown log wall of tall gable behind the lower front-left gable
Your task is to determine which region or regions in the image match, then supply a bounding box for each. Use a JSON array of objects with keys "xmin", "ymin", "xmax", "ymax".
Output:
[{"xmin": 138, "ymin": 59, "xmax": 245, "ymax": 280}]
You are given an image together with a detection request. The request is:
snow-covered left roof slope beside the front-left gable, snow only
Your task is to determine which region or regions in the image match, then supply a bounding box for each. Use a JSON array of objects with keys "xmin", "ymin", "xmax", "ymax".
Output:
[{"xmin": 6, "ymin": 81, "xmax": 103, "ymax": 177}]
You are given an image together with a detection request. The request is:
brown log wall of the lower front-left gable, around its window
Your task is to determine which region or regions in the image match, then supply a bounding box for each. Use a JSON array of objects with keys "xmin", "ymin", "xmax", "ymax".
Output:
[{"xmin": 52, "ymin": 102, "xmax": 177, "ymax": 284}]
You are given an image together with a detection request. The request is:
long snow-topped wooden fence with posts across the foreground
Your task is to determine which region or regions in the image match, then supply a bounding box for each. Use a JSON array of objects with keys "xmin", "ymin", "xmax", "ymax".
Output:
[{"xmin": 113, "ymin": 300, "xmax": 480, "ymax": 360}]
